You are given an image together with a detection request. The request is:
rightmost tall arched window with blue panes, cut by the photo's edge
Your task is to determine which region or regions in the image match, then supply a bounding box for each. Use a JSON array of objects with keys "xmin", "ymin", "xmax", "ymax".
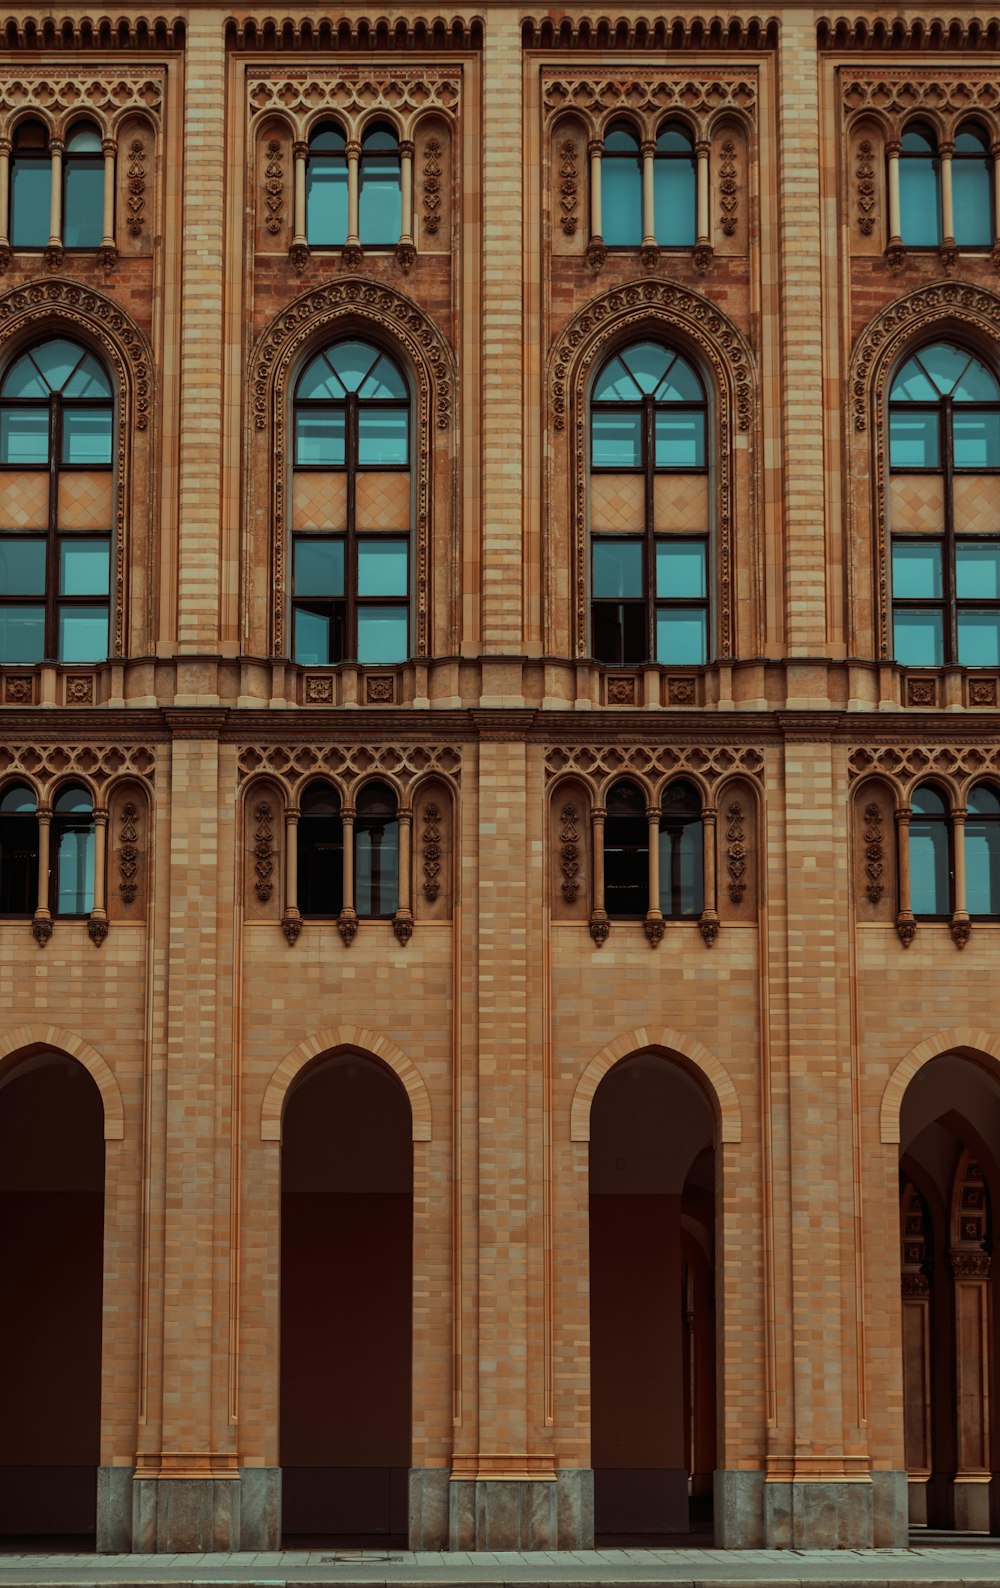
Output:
[{"xmin": 889, "ymin": 341, "xmax": 1000, "ymax": 667}]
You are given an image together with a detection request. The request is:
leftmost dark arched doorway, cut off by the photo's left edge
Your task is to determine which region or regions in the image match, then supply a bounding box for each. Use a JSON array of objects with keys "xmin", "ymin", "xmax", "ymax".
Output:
[{"xmin": 0, "ymin": 1050, "xmax": 105, "ymax": 1547}]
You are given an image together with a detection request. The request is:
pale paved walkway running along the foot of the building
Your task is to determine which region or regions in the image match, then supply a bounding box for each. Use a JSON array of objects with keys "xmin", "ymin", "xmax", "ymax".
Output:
[{"xmin": 0, "ymin": 1539, "xmax": 1000, "ymax": 1588}]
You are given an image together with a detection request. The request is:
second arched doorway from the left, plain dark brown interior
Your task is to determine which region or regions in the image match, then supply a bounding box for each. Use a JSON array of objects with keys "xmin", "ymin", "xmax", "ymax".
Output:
[{"xmin": 279, "ymin": 1051, "xmax": 413, "ymax": 1544}]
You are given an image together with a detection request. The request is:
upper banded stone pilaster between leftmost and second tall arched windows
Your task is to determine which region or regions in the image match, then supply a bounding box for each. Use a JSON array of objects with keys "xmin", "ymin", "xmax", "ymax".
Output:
[{"xmin": 178, "ymin": 11, "xmax": 225, "ymax": 653}]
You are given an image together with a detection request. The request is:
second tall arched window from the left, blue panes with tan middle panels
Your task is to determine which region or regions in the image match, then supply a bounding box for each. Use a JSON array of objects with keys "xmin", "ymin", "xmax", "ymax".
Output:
[{"xmin": 292, "ymin": 340, "xmax": 411, "ymax": 665}]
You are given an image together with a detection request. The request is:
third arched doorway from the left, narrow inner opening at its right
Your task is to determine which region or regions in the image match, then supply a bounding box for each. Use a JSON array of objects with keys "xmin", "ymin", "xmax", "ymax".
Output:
[{"xmin": 590, "ymin": 1053, "xmax": 716, "ymax": 1542}]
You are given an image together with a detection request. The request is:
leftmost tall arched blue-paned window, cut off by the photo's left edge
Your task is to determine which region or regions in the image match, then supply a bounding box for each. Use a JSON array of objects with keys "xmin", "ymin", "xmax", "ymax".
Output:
[{"xmin": 0, "ymin": 337, "xmax": 114, "ymax": 664}]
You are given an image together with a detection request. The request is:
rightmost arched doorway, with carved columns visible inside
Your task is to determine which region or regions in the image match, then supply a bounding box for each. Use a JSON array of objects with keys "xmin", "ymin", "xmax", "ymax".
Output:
[{"xmin": 900, "ymin": 1053, "xmax": 1000, "ymax": 1532}]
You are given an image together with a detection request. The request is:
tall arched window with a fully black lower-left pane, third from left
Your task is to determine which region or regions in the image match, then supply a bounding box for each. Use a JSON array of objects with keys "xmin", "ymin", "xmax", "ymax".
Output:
[{"xmin": 590, "ymin": 341, "xmax": 710, "ymax": 665}]
